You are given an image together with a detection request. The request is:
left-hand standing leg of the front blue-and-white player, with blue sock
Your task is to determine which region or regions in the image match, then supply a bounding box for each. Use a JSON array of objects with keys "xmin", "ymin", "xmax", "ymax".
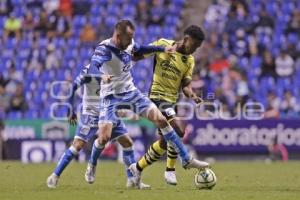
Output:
[{"xmin": 85, "ymin": 122, "xmax": 113, "ymax": 184}]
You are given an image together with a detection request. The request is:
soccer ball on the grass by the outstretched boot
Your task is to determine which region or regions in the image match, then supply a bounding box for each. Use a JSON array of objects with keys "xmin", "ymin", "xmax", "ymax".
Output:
[{"xmin": 194, "ymin": 168, "xmax": 217, "ymax": 189}]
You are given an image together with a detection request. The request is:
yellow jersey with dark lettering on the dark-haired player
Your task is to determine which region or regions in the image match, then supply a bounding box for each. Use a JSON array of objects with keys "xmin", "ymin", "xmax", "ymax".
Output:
[{"xmin": 150, "ymin": 38, "xmax": 195, "ymax": 103}]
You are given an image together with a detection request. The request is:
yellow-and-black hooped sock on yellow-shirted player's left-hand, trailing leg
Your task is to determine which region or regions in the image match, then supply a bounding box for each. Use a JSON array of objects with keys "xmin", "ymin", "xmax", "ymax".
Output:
[{"xmin": 137, "ymin": 141, "xmax": 166, "ymax": 171}]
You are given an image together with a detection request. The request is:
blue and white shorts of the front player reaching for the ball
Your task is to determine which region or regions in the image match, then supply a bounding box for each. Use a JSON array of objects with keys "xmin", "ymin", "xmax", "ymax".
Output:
[{"xmin": 99, "ymin": 89, "xmax": 155, "ymax": 126}]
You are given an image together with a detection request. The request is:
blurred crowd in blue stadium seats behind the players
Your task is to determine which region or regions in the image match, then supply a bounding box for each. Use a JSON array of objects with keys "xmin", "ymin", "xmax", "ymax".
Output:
[{"xmin": 0, "ymin": 0, "xmax": 300, "ymax": 119}]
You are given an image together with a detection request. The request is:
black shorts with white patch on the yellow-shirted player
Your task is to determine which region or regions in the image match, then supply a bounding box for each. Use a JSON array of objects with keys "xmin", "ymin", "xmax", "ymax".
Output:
[{"xmin": 151, "ymin": 99, "xmax": 177, "ymax": 121}]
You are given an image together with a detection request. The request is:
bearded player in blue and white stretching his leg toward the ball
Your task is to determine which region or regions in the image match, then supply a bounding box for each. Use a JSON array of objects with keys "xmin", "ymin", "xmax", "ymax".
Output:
[{"xmin": 82, "ymin": 20, "xmax": 209, "ymax": 188}]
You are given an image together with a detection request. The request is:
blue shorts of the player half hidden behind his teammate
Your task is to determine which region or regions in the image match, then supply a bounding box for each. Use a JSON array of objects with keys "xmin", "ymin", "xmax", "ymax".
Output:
[{"xmin": 75, "ymin": 114, "xmax": 128, "ymax": 142}]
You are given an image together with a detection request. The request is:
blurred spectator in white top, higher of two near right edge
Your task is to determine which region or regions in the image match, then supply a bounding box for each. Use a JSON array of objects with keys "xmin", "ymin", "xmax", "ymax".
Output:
[{"xmin": 275, "ymin": 51, "xmax": 294, "ymax": 77}]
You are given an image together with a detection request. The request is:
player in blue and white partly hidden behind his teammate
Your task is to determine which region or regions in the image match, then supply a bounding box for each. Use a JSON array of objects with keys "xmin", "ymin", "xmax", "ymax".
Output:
[{"xmin": 47, "ymin": 65, "xmax": 150, "ymax": 189}]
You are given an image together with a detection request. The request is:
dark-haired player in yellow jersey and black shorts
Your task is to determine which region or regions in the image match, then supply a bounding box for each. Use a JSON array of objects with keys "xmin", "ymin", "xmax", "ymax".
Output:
[{"xmin": 136, "ymin": 25, "xmax": 205, "ymax": 185}]
